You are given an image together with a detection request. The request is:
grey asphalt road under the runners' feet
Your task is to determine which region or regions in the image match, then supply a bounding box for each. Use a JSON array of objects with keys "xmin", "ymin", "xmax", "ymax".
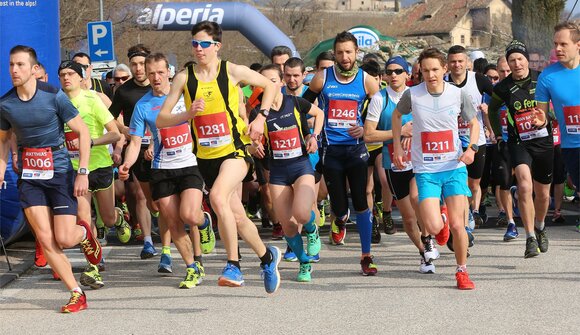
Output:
[{"xmin": 0, "ymin": 211, "xmax": 580, "ymax": 334}]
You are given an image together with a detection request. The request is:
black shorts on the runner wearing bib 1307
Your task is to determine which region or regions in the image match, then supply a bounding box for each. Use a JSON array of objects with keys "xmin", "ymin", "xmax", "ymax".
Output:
[{"xmin": 150, "ymin": 166, "xmax": 203, "ymax": 200}]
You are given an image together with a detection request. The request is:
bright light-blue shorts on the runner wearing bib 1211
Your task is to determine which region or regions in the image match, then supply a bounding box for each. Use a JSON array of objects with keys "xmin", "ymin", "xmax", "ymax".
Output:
[{"xmin": 415, "ymin": 166, "xmax": 471, "ymax": 202}]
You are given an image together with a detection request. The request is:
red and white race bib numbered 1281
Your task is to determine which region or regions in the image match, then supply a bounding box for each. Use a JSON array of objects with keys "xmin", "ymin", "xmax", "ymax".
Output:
[{"xmin": 193, "ymin": 112, "xmax": 232, "ymax": 148}]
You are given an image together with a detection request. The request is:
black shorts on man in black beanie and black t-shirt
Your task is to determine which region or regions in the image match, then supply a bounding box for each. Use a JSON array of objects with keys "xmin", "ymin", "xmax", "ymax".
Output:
[{"xmin": 508, "ymin": 138, "xmax": 554, "ymax": 184}]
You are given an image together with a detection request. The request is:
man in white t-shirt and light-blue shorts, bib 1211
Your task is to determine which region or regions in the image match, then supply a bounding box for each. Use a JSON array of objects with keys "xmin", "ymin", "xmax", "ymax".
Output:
[{"xmin": 392, "ymin": 48, "xmax": 480, "ymax": 290}]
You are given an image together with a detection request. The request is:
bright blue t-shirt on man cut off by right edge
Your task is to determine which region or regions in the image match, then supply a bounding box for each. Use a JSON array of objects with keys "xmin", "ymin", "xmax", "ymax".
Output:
[{"xmin": 536, "ymin": 63, "xmax": 580, "ymax": 149}]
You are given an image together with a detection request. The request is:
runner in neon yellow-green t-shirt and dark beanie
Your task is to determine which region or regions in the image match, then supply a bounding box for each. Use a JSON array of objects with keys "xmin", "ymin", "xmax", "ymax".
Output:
[{"xmin": 58, "ymin": 61, "xmax": 131, "ymax": 289}]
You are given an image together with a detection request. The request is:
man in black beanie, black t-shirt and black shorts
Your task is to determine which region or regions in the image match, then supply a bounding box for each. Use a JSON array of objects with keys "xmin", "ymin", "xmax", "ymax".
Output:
[{"xmin": 489, "ymin": 40, "xmax": 554, "ymax": 258}]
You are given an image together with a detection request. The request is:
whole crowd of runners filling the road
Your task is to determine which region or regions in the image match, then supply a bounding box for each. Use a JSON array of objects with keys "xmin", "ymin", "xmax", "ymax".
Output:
[{"xmin": 0, "ymin": 21, "xmax": 580, "ymax": 312}]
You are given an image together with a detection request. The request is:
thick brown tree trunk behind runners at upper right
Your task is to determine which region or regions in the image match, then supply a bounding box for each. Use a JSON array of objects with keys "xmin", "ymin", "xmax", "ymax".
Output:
[{"xmin": 512, "ymin": 0, "xmax": 566, "ymax": 54}]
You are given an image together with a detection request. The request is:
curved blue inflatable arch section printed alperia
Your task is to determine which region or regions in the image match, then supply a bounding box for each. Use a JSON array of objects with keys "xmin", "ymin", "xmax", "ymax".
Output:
[{"xmin": 137, "ymin": 2, "xmax": 299, "ymax": 57}]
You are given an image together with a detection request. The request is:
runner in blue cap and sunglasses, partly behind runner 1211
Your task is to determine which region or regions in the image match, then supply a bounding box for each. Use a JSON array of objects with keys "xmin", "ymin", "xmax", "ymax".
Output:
[{"xmin": 365, "ymin": 56, "xmax": 439, "ymax": 273}]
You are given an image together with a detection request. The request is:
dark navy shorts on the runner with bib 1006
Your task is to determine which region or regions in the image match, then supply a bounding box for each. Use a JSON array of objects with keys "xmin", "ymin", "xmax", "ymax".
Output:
[{"xmin": 18, "ymin": 170, "xmax": 77, "ymax": 216}]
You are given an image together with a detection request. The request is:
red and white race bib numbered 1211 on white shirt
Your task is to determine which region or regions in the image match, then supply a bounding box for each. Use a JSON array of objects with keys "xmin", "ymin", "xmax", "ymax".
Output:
[{"xmin": 421, "ymin": 130, "xmax": 457, "ymax": 163}]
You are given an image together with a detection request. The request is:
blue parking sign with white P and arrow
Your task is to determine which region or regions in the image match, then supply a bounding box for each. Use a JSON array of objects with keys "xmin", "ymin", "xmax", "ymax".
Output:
[{"xmin": 87, "ymin": 21, "xmax": 115, "ymax": 62}]
